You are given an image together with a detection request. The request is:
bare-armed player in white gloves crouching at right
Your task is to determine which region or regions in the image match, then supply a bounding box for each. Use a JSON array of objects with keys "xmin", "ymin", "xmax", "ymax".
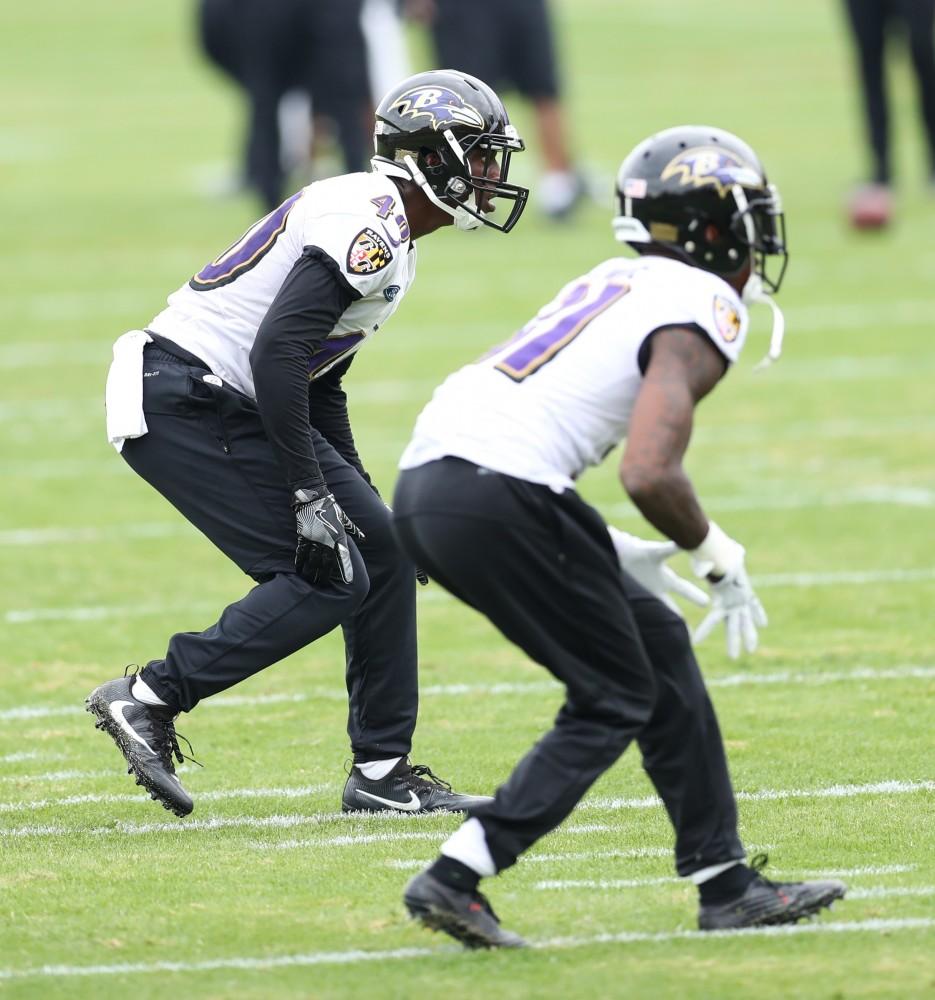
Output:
[{"xmin": 394, "ymin": 126, "xmax": 844, "ymax": 947}]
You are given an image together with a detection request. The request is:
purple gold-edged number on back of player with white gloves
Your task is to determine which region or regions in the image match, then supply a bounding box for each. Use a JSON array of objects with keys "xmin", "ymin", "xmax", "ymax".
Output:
[{"xmin": 487, "ymin": 277, "xmax": 630, "ymax": 382}]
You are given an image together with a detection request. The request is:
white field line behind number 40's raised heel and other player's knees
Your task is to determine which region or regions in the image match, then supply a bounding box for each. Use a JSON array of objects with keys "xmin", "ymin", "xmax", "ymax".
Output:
[{"xmin": 0, "ymin": 664, "xmax": 935, "ymax": 728}]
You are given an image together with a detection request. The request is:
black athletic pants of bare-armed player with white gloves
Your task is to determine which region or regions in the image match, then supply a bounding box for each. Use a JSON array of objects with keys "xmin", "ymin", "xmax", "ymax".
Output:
[{"xmin": 394, "ymin": 458, "xmax": 744, "ymax": 875}]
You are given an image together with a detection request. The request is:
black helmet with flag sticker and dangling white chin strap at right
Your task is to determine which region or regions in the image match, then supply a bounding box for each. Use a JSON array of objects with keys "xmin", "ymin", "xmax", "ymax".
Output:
[{"xmin": 613, "ymin": 125, "xmax": 789, "ymax": 292}]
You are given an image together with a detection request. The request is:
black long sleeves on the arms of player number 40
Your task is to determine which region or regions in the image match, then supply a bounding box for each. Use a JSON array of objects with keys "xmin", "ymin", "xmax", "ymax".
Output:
[{"xmin": 250, "ymin": 247, "xmax": 361, "ymax": 490}]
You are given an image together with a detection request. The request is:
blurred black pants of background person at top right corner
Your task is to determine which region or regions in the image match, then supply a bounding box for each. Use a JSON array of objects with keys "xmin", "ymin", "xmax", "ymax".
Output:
[{"xmin": 846, "ymin": 0, "xmax": 935, "ymax": 184}]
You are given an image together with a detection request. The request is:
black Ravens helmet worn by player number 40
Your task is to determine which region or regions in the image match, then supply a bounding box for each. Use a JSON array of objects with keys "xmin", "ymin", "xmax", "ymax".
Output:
[{"xmin": 371, "ymin": 69, "xmax": 529, "ymax": 233}]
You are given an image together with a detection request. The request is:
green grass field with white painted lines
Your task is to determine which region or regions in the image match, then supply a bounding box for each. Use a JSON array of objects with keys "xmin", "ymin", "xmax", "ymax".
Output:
[{"xmin": 0, "ymin": 0, "xmax": 935, "ymax": 1000}]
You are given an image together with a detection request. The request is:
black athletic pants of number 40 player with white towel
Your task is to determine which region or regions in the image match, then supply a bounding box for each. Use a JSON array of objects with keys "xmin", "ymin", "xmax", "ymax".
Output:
[{"xmin": 123, "ymin": 344, "xmax": 418, "ymax": 760}]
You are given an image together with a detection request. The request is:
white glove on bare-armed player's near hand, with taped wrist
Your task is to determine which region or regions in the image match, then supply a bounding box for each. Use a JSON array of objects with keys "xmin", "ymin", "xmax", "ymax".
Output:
[{"xmin": 689, "ymin": 521, "xmax": 767, "ymax": 660}]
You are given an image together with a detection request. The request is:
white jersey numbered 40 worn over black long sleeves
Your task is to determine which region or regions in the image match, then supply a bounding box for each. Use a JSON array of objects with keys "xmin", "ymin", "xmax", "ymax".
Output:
[{"xmin": 148, "ymin": 173, "xmax": 416, "ymax": 398}]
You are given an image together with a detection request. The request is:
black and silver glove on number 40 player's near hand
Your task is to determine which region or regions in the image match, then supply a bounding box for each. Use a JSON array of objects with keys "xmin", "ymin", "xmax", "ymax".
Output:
[{"xmin": 292, "ymin": 486, "xmax": 364, "ymax": 583}]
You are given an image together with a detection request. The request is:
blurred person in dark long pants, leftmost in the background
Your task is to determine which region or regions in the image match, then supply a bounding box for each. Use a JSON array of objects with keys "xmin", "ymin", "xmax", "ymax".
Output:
[{"xmin": 198, "ymin": 0, "xmax": 372, "ymax": 209}]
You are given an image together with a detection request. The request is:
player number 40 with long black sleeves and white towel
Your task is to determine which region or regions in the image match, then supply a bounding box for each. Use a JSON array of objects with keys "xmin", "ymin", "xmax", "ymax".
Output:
[{"xmin": 87, "ymin": 70, "xmax": 528, "ymax": 816}]
